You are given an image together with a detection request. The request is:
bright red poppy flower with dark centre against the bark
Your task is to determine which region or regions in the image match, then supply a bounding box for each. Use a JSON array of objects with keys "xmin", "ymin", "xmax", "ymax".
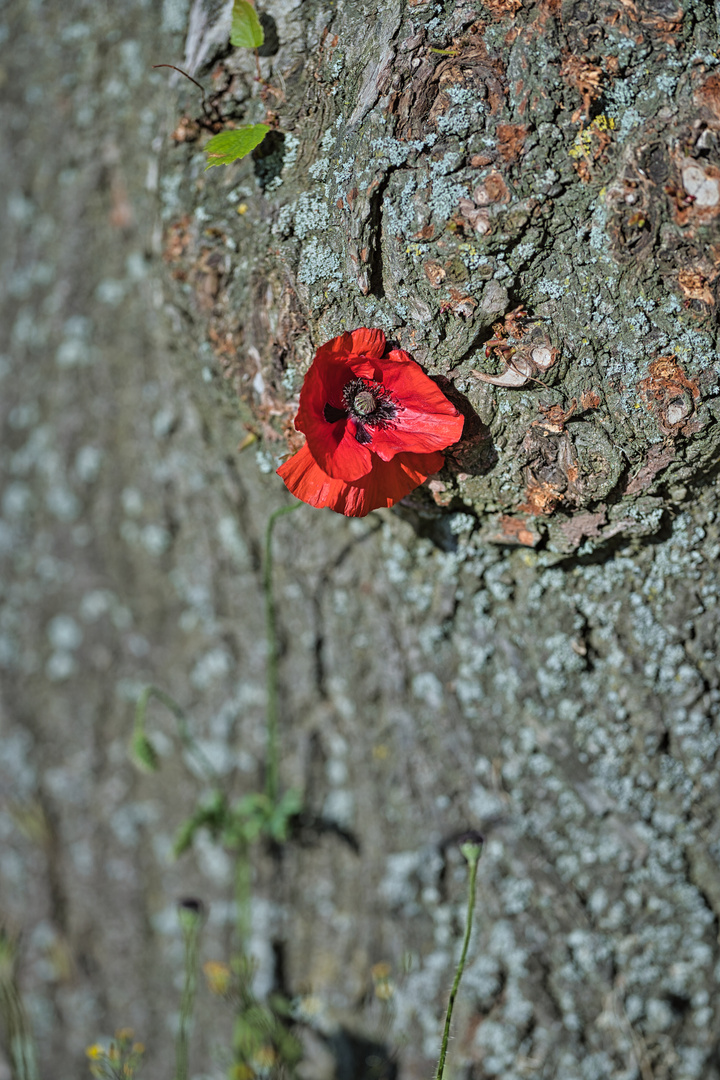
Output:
[{"xmin": 277, "ymin": 328, "xmax": 463, "ymax": 517}]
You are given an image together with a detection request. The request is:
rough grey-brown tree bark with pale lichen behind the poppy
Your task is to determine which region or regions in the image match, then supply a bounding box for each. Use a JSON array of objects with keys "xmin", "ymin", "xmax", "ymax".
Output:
[{"xmin": 0, "ymin": 0, "xmax": 720, "ymax": 1080}]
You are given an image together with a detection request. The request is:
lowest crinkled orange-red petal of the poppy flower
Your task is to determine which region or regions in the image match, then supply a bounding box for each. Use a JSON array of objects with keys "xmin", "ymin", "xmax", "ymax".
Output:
[{"xmin": 277, "ymin": 444, "xmax": 445, "ymax": 517}]
